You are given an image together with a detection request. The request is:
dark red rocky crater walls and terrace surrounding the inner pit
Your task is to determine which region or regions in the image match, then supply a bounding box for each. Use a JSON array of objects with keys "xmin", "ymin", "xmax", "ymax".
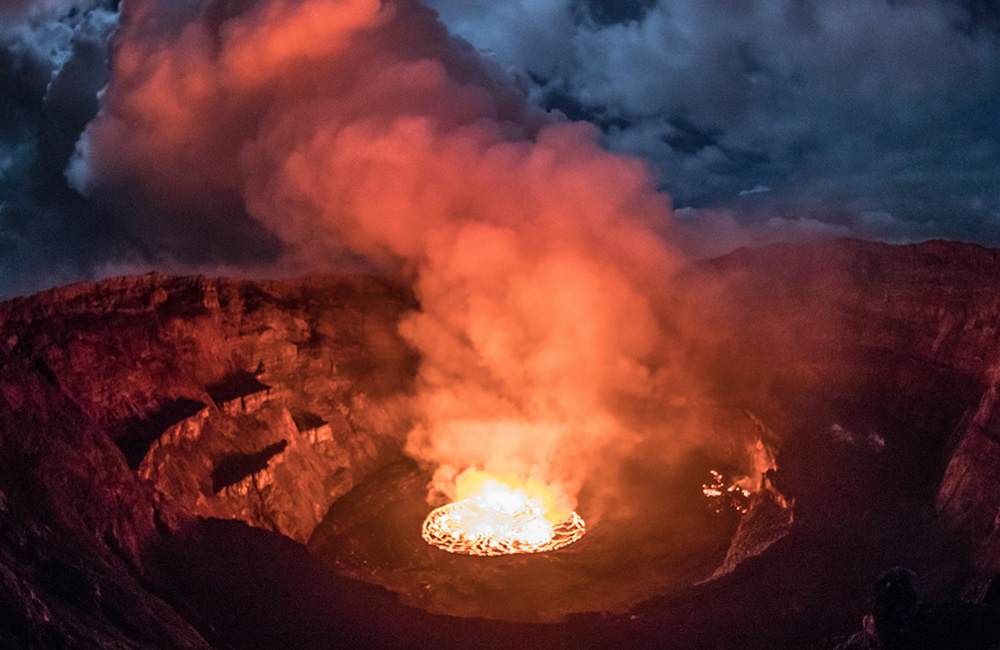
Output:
[{"xmin": 0, "ymin": 241, "xmax": 1000, "ymax": 648}]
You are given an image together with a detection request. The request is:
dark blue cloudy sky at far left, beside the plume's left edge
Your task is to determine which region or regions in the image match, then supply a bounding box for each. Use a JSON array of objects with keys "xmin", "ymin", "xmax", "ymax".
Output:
[{"xmin": 0, "ymin": 0, "xmax": 127, "ymax": 296}]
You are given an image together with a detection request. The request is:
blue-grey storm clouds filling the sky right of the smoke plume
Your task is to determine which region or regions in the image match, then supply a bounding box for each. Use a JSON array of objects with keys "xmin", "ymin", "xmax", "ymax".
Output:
[{"xmin": 430, "ymin": 0, "xmax": 1000, "ymax": 253}]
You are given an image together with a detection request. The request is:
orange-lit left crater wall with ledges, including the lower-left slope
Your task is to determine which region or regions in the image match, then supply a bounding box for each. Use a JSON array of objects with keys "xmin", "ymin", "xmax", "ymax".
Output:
[{"xmin": 0, "ymin": 275, "xmax": 415, "ymax": 647}]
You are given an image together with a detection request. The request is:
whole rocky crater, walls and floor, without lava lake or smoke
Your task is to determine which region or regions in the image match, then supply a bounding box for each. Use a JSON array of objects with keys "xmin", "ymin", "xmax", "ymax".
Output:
[{"xmin": 0, "ymin": 242, "xmax": 1000, "ymax": 648}]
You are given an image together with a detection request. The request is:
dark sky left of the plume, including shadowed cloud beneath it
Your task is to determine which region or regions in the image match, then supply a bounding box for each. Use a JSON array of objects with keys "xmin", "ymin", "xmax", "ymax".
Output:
[{"xmin": 0, "ymin": 0, "xmax": 290, "ymax": 297}]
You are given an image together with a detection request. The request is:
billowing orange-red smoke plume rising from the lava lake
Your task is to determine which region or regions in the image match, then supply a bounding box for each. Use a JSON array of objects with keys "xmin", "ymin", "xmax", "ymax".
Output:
[{"xmin": 70, "ymin": 0, "xmax": 704, "ymax": 505}]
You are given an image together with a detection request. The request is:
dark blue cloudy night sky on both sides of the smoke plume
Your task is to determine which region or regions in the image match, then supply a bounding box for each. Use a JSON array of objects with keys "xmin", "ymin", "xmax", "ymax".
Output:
[{"xmin": 0, "ymin": 0, "xmax": 1000, "ymax": 298}]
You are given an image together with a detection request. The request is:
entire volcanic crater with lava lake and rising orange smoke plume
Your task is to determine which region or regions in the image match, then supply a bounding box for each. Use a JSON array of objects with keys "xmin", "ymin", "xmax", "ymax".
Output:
[{"xmin": 0, "ymin": 0, "xmax": 1000, "ymax": 647}]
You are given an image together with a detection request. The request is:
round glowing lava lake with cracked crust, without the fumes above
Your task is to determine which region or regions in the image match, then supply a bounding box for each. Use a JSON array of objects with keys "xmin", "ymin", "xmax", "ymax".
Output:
[{"xmin": 421, "ymin": 499, "xmax": 586, "ymax": 555}]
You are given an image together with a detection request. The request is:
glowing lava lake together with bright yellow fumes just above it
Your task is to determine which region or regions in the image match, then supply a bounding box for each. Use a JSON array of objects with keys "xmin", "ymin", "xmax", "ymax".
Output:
[{"xmin": 421, "ymin": 472, "xmax": 585, "ymax": 555}]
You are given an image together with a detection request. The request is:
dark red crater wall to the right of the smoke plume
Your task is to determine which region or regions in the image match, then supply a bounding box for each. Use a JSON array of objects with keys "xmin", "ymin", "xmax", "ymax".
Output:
[{"xmin": 706, "ymin": 241, "xmax": 1000, "ymax": 576}]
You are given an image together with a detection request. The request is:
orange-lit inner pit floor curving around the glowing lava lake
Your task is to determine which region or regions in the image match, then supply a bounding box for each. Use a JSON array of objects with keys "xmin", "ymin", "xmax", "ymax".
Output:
[{"xmin": 309, "ymin": 403, "xmax": 776, "ymax": 622}]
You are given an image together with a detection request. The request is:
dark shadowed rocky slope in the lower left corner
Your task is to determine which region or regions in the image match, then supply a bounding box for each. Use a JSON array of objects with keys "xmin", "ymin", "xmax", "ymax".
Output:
[{"xmin": 0, "ymin": 368, "xmax": 208, "ymax": 649}]
